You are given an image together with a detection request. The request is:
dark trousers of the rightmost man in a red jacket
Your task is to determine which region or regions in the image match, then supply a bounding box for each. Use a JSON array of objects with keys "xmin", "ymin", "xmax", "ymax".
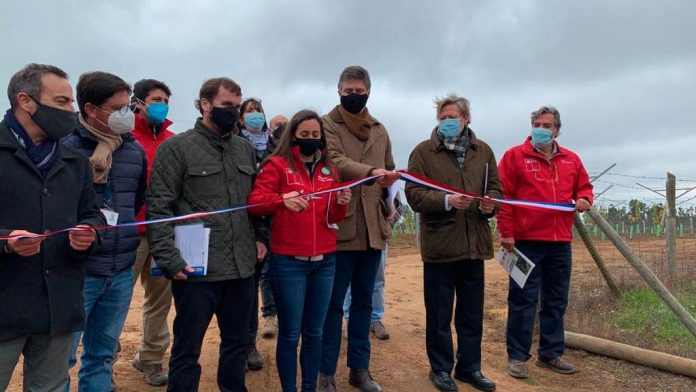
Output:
[{"xmin": 507, "ymin": 241, "xmax": 572, "ymax": 361}]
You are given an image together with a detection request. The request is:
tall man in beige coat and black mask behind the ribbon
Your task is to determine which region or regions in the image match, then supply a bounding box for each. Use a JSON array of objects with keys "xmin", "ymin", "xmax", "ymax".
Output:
[{"xmin": 319, "ymin": 66, "xmax": 399, "ymax": 392}]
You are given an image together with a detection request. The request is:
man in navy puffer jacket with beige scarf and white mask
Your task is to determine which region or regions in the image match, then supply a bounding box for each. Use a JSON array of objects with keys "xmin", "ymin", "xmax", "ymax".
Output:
[{"xmin": 63, "ymin": 72, "xmax": 147, "ymax": 391}]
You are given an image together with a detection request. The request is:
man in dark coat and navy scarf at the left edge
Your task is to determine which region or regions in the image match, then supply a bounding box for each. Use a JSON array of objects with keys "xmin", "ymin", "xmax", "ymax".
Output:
[{"xmin": 0, "ymin": 64, "xmax": 105, "ymax": 391}]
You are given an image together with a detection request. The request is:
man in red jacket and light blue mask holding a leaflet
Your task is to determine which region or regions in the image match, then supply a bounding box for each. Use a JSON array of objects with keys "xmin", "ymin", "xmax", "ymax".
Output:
[{"xmin": 498, "ymin": 106, "xmax": 593, "ymax": 378}]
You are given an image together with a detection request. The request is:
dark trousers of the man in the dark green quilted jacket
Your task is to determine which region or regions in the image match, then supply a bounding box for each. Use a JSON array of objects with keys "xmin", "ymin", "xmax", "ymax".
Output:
[{"xmin": 167, "ymin": 277, "xmax": 254, "ymax": 392}]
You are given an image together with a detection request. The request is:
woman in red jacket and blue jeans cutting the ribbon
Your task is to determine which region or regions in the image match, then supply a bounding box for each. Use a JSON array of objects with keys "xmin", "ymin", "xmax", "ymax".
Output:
[{"xmin": 249, "ymin": 110, "xmax": 351, "ymax": 391}]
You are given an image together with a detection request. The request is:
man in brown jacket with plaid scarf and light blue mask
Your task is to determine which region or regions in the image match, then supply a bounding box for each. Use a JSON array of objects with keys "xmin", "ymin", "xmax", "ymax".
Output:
[{"xmin": 406, "ymin": 95, "xmax": 502, "ymax": 392}]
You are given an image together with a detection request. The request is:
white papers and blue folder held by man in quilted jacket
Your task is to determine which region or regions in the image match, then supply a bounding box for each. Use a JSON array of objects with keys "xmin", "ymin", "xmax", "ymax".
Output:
[{"xmin": 150, "ymin": 223, "xmax": 210, "ymax": 276}]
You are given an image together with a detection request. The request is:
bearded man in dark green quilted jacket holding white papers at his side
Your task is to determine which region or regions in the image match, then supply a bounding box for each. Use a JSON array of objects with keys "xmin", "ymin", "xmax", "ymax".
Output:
[{"xmin": 147, "ymin": 78, "xmax": 267, "ymax": 392}]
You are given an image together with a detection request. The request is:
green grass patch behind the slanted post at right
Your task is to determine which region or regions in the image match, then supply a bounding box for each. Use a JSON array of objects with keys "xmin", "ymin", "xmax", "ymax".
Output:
[{"xmin": 609, "ymin": 280, "xmax": 696, "ymax": 351}]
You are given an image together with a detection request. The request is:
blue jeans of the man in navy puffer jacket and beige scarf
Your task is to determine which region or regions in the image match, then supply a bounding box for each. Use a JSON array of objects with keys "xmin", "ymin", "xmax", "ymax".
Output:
[{"xmin": 65, "ymin": 268, "xmax": 133, "ymax": 392}]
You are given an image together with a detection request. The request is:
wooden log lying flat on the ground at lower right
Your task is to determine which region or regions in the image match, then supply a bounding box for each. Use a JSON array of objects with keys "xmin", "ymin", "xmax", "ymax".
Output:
[{"xmin": 565, "ymin": 331, "xmax": 696, "ymax": 378}]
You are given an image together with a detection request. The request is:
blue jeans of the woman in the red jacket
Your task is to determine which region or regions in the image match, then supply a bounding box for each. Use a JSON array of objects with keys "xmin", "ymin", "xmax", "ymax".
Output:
[{"xmin": 271, "ymin": 253, "xmax": 336, "ymax": 391}]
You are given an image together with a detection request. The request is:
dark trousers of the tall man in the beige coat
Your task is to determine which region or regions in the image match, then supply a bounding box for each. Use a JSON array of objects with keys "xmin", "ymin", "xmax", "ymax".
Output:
[{"xmin": 319, "ymin": 249, "xmax": 382, "ymax": 375}]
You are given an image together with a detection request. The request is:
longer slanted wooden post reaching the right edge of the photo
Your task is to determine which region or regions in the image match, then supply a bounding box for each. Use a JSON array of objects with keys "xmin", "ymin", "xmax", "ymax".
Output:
[{"xmin": 587, "ymin": 207, "xmax": 696, "ymax": 336}]
